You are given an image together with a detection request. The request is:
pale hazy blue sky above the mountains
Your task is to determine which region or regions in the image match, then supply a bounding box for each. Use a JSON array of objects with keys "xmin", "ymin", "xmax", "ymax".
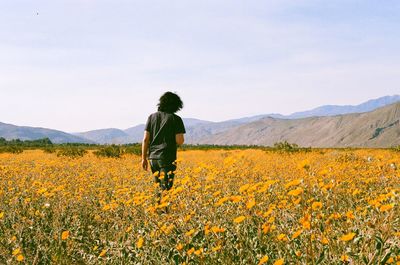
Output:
[{"xmin": 0, "ymin": 0, "xmax": 400, "ymax": 132}]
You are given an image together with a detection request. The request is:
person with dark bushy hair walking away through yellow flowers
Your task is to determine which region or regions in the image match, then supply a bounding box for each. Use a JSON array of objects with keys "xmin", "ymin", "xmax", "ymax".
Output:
[{"xmin": 142, "ymin": 92, "xmax": 186, "ymax": 191}]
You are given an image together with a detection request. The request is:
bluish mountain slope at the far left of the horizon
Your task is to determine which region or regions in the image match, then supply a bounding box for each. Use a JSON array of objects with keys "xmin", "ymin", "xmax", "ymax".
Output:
[{"xmin": 0, "ymin": 122, "xmax": 93, "ymax": 143}]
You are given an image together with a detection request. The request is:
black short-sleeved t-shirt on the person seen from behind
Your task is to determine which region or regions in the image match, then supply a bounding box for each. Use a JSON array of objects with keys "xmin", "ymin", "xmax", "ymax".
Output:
[{"xmin": 145, "ymin": 111, "xmax": 186, "ymax": 163}]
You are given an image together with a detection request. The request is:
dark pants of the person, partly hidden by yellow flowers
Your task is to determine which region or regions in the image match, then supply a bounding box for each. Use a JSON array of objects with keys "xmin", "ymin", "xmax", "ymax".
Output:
[{"xmin": 150, "ymin": 159, "xmax": 176, "ymax": 191}]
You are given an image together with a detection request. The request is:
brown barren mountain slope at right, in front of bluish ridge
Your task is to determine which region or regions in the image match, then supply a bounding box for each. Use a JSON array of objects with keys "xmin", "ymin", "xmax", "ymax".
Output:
[{"xmin": 197, "ymin": 102, "xmax": 400, "ymax": 147}]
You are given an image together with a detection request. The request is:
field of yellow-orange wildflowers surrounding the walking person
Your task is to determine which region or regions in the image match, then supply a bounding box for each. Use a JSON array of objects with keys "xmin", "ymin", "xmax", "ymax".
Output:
[{"xmin": 0, "ymin": 149, "xmax": 400, "ymax": 264}]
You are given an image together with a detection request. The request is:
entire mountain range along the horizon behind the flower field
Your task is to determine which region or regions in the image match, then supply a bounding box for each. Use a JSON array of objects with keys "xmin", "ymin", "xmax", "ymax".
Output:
[{"xmin": 0, "ymin": 95, "xmax": 400, "ymax": 147}]
